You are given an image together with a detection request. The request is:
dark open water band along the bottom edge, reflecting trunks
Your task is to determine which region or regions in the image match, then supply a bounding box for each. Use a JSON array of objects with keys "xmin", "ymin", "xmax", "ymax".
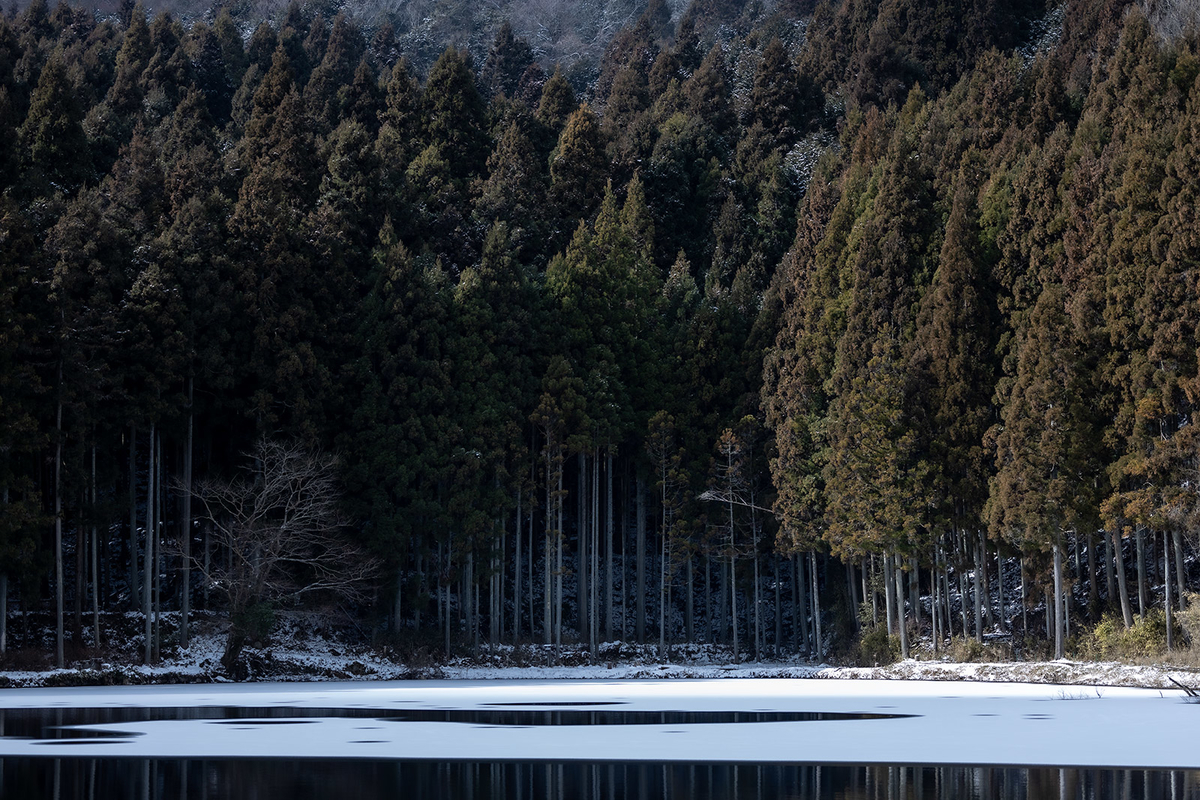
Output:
[{"xmin": 0, "ymin": 758, "xmax": 1200, "ymax": 800}]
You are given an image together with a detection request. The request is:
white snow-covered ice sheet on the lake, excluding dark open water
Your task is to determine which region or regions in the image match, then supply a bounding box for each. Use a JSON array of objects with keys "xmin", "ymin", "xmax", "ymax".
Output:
[{"xmin": 0, "ymin": 679, "xmax": 1200, "ymax": 769}]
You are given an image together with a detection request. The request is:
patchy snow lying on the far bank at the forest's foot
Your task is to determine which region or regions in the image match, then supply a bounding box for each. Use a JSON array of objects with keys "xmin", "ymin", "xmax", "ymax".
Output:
[{"xmin": 7, "ymin": 618, "xmax": 1200, "ymax": 688}]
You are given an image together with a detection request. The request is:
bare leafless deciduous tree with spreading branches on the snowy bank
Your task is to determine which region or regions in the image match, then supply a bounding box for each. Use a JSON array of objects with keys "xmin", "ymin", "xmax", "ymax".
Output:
[{"xmin": 182, "ymin": 439, "xmax": 377, "ymax": 670}]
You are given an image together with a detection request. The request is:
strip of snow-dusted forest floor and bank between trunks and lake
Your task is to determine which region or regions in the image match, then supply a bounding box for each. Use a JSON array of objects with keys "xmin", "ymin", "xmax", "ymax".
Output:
[{"xmin": 0, "ymin": 614, "xmax": 1200, "ymax": 690}]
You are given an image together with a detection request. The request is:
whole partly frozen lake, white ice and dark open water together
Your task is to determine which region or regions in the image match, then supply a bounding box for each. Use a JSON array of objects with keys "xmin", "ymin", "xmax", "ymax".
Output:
[{"xmin": 0, "ymin": 679, "xmax": 1200, "ymax": 800}]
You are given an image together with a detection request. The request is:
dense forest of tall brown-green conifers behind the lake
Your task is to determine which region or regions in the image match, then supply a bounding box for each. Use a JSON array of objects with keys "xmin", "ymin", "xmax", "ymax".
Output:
[{"xmin": 0, "ymin": 0, "xmax": 1200, "ymax": 664}]
